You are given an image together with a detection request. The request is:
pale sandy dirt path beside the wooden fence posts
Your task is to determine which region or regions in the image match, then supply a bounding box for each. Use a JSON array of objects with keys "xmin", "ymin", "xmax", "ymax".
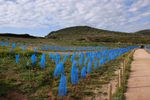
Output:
[{"xmin": 125, "ymin": 49, "xmax": 150, "ymax": 100}]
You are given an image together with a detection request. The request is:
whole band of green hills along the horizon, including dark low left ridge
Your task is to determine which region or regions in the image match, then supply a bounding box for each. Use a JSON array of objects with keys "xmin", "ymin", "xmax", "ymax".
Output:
[{"xmin": 0, "ymin": 26, "xmax": 150, "ymax": 47}]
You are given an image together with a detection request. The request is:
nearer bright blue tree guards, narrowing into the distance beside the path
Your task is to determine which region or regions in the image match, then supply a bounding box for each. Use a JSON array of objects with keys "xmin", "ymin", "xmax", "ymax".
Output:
[{"xmin": 16, "ymin": 46, "xmax": 137, "ymax": 96}]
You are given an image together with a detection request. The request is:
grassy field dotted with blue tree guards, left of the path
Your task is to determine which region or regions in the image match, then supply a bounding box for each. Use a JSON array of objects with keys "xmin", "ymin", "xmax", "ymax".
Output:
[{"xmin": 0, "ymin": 41, "xmax": 137, "ymax": 99}]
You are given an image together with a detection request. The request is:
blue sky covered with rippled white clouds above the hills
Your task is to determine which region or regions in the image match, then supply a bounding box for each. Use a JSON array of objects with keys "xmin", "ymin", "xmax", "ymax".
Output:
[{"xmin": 0, "ymin": 0, "xmax": 150, "ymax": 36}]
